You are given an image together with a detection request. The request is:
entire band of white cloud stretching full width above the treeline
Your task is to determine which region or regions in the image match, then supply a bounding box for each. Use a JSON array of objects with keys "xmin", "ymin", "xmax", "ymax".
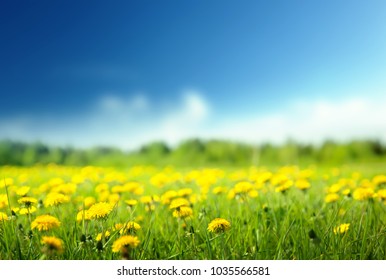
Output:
[{"xmin": 0, "ymin": 90, "xmax": 386, "ymax": 149}]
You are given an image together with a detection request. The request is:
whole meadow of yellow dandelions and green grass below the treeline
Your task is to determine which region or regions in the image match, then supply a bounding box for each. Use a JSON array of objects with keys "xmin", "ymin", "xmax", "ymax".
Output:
[{"xmin": 0, "ymin": 165, "xmax": 386, "ymax": 260}]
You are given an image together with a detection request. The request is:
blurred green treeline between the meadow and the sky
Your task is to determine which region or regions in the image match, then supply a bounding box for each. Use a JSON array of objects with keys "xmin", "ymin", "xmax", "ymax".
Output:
[{"xmin": 0, "ymin": 139, "xmax": 386, "ymax": 167}]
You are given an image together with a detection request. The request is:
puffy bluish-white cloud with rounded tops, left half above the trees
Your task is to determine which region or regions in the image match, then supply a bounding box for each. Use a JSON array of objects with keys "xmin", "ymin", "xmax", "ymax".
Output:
[{"xmin": 0, "ymin": 90, "xmax": 210, "ymax": 149}]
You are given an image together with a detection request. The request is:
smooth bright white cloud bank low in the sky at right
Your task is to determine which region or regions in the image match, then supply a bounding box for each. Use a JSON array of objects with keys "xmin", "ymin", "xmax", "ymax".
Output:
[{"xmin": 207, "ymin": 97, "xmax": 386, "ymax": 143}]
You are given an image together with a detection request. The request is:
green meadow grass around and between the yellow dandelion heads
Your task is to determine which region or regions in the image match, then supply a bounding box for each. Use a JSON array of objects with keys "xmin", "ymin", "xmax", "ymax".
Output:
[{"xmin": 0, "ymin": 166, "xmax": 386, "ymax": 260}]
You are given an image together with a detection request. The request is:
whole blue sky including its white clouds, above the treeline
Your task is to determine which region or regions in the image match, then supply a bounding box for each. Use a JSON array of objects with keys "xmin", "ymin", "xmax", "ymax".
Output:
[{"xmin": 0, "ymin": 0, "xmax": 386, "ymax": 149}]
